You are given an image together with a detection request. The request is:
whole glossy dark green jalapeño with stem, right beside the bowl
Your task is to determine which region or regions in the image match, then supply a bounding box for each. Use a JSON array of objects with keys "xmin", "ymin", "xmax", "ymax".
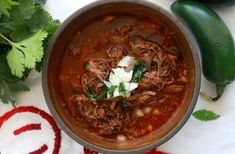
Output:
[{"xmin": 171, "ymin": 0, "xmax": 235, "ymax": 101}]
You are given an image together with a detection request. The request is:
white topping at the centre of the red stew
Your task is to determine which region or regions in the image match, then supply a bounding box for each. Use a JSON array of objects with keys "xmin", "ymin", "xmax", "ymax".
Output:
[{"xmin": 103, "ymin": 56, "xmax": 138, "ymax": 98}]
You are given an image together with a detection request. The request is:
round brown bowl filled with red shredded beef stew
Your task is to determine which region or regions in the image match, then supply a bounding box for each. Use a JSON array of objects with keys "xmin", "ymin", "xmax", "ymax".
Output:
[{"xmin": 42, "ymin": 0, "xmax": 200, "ymax": 153}]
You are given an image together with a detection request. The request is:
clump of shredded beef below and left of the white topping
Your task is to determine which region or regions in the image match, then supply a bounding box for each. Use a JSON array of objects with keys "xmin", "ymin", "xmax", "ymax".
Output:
[{"xmin": 73, "ymin": 96, "xmax": 133, "ymax": 135}]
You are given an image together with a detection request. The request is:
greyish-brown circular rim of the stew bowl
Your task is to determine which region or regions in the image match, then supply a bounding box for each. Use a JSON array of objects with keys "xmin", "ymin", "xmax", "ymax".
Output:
[{"xmin": 42, "ymin": 0, "xmax": 201, "ymax": 154}]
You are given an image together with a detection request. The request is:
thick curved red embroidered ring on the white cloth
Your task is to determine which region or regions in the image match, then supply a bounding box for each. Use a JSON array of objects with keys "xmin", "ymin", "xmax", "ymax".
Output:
[{"xmin": 0, "ymin": 106, "xmax": 61, "ymax": 154}]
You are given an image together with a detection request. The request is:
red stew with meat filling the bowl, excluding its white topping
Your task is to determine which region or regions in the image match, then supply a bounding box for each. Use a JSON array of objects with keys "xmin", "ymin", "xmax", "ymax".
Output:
[{"xmin": 58, "ymin": 14, "xmax": 188, "ymax": 141}]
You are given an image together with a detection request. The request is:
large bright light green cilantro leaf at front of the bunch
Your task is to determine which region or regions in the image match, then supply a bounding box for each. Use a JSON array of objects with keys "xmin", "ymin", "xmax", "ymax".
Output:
[{"xmin": 0, "ymin": 30, "xmax": 47, "ymax": 78}]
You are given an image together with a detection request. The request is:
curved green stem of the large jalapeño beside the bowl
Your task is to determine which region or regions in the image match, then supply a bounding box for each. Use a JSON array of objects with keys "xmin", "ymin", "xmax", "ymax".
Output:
[{"xmin": 200, "ymin": 84, "xmax": 227, "ymax": 102}]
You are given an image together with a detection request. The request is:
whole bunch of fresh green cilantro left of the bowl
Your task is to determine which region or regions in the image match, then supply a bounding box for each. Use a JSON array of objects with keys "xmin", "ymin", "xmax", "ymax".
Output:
[{"xmin": 0, "ymin": 0, "xmax": 60, "ymax": 106}]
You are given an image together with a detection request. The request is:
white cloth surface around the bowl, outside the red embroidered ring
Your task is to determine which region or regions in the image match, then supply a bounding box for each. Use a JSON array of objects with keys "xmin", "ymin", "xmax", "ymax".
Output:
[{"xmin": 0, "ymin": 0, "xmax": 235, "ymax": 154}]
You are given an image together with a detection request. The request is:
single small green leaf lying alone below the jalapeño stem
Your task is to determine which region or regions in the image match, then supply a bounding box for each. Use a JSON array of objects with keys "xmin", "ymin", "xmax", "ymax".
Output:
[{"xmin": 193, "ymin": 109, "xmax": 220, "ymax": 121}]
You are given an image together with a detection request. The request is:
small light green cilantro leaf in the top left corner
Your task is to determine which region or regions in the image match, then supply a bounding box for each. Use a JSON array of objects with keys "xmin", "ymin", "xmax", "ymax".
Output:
[{"xmin": 0, "ymin": 0, "xmax": 18, "ymax": 17}]
